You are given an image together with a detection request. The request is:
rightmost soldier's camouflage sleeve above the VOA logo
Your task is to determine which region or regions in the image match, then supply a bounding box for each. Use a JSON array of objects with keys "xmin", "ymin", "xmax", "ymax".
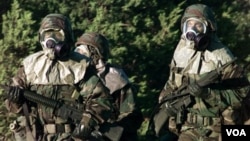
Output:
[{"xmin": 203, "ymin": 63, "xmax": 250, "ymax": 124}]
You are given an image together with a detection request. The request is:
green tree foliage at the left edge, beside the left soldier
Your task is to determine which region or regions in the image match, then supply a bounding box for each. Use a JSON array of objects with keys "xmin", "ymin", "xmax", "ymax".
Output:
[{"xmin": 0, "ymin": 0, "xmax": 37, "ymax": 140}]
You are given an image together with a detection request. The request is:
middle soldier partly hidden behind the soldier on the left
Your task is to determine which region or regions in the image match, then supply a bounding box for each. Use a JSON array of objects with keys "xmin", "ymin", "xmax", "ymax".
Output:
[{"xmin": 75, "ymin": 32, "xmax": 142, "ymax": 141}]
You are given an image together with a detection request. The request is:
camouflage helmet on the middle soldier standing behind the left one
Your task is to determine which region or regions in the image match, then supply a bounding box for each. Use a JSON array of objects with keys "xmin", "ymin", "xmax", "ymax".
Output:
[{"xmin": 75, "ymin": 32, "xmax": 109, "ymax": 61}]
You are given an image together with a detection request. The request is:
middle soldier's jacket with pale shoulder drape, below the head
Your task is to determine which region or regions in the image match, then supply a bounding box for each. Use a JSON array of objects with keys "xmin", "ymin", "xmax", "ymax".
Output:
[{"xmin": 99, "ymin": 64, "xmax": 142, "ymax": 133}]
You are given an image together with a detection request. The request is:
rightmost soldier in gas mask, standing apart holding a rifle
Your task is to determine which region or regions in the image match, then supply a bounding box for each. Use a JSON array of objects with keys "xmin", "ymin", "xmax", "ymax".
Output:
[{"xmin": 149, "ymin": 4, "xmax": 249, "ymax": 141}]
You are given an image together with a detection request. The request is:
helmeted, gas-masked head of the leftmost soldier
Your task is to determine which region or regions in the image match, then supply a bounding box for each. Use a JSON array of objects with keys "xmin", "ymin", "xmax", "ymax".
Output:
[{"xmin": 39, "ymin": 14, "xmax": 74, "ymax": 59}]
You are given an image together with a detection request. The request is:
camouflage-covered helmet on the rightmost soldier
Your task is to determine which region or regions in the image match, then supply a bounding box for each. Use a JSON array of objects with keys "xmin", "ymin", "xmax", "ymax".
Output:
[{"xmin": 181, "ymin": 4, "xmax": 217, "ymax": 31}]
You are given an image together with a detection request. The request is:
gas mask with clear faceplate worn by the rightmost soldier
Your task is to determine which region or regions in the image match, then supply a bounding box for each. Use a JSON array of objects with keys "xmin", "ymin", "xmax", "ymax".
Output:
[{"xmin": 183, "ymin": 18, "xmax": 209, "ymax": 51}]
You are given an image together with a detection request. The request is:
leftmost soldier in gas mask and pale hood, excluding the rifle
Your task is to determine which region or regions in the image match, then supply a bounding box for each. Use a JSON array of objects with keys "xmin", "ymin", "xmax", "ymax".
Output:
[{"xmin": 6, "ymin": 14, "xmax": 113, "ymax": 141}]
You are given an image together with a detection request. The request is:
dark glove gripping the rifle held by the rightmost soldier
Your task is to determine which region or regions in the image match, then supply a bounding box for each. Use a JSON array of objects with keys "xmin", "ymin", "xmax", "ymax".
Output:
[{"xmin": 187, "ymin": 83, "xmax": 208, "ymax": 98}]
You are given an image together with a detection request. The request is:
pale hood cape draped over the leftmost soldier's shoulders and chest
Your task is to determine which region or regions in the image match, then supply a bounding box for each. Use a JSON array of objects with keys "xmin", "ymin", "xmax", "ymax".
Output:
[{"xmin": 23, "ymin": 51, "xmax": 89, "ymax": 85}]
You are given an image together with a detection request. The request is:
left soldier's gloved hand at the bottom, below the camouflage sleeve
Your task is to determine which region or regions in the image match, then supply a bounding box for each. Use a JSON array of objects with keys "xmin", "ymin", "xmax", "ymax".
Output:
[{"xmin": 72, "ymin": 113, "xmax": 95, "ymax": 139}]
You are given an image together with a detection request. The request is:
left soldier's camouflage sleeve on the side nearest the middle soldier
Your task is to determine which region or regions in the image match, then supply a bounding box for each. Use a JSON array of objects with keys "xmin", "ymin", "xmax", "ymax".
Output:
[{"xmin": 80, "ymin": 75, "xmax": 114, "ymax": 124}]
